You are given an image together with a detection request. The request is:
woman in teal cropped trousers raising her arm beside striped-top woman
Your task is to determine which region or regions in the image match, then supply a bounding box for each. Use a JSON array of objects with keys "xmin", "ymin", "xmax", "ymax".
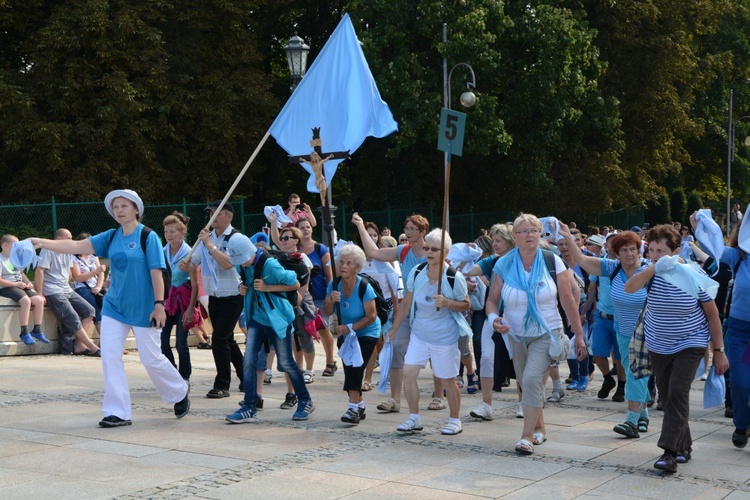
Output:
[{"xmin": 560, "ymin": 224, "xmax": 651, "ymax": 438}]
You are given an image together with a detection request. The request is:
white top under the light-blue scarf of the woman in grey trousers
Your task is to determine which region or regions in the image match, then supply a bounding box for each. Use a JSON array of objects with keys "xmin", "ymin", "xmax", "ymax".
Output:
[{"xmin": 502, "ymin": 255, "xmax": 566, "ymax": 337}]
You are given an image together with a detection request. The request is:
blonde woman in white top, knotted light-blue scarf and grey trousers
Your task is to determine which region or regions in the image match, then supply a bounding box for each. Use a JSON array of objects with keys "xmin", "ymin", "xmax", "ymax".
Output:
[{"xmin": 486, "ymin": 214, "xmax": 586, "ymax": 455}]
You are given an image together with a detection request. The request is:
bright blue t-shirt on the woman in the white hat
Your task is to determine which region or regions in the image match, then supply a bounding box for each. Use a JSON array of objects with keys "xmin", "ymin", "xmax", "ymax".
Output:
[{"xmin": 89, "ymin": 224, "xmax": 166, "ymax": 328}]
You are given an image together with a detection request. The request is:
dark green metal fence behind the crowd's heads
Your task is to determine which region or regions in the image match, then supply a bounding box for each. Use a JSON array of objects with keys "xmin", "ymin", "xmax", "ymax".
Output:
[{"xmin": 0, "ymin": 197, "xmax": 644, "ymax": 242}]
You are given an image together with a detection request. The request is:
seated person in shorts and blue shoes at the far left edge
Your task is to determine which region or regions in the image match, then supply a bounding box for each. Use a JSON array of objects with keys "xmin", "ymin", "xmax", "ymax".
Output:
[{"xmin": 0, "ymin": 234, "xmax": 49, "ymax": 345}]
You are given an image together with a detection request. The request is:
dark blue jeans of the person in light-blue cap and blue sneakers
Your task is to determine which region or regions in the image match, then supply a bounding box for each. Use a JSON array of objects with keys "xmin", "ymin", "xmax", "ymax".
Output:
[{"xmin": 242, "ymin": 319, "xmax": 310, "ymax": 408}]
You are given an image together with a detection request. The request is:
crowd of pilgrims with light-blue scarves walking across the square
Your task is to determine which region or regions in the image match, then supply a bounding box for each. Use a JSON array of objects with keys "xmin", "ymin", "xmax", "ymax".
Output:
[{"xmin": 20, "ymin": 190, "xmax": 750, "ymax": 473}]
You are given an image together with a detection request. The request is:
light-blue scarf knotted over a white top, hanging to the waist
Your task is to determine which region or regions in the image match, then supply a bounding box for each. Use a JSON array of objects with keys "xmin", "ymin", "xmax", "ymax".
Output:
[{"xmin": 495, "ymin": 248, "xmax": 552, "ymax": 335}]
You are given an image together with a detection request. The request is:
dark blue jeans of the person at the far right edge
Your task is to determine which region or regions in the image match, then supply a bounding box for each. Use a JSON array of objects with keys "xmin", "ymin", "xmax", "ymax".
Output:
[{"xmin": 724, "ymin": 317, "xmax": 750, "ymax": 429}]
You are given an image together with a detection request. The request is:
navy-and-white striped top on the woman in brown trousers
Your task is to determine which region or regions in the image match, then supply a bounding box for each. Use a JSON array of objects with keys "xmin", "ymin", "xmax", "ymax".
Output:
[{"xmin": 642, "ymin": 274, "xmax": 711, "ymax": 354}]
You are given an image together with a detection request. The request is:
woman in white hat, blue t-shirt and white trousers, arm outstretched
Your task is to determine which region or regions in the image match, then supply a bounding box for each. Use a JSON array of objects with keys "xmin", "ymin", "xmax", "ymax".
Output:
[{"xmin": 32, "ymin": 189, "xmax": 190, "ymax": 427}]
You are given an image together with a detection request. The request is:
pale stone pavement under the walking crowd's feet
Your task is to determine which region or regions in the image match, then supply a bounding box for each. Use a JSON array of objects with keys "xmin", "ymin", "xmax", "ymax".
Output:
[{"xmin": 0, "ymin": 349, "xmax": 750, "ymax": 500}]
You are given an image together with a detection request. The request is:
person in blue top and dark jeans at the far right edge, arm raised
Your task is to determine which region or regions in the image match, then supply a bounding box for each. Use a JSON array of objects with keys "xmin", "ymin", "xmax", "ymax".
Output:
[{"xmin": 690, "ymin": 211, "xmax": 750, "ymax": 448}]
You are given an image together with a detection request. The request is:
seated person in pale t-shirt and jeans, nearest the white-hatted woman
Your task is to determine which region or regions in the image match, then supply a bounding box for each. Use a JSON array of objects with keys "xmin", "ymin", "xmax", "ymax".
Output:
[{"xmin": 34, "ymin": 228, "xmax": 103, "ymax": 357}]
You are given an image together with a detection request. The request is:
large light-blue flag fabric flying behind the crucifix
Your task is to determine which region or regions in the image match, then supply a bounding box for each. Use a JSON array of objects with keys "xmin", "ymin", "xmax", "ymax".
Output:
[{"xmin": 269, "ymin": 14, "xmax": 398, "ymax": 193}]
